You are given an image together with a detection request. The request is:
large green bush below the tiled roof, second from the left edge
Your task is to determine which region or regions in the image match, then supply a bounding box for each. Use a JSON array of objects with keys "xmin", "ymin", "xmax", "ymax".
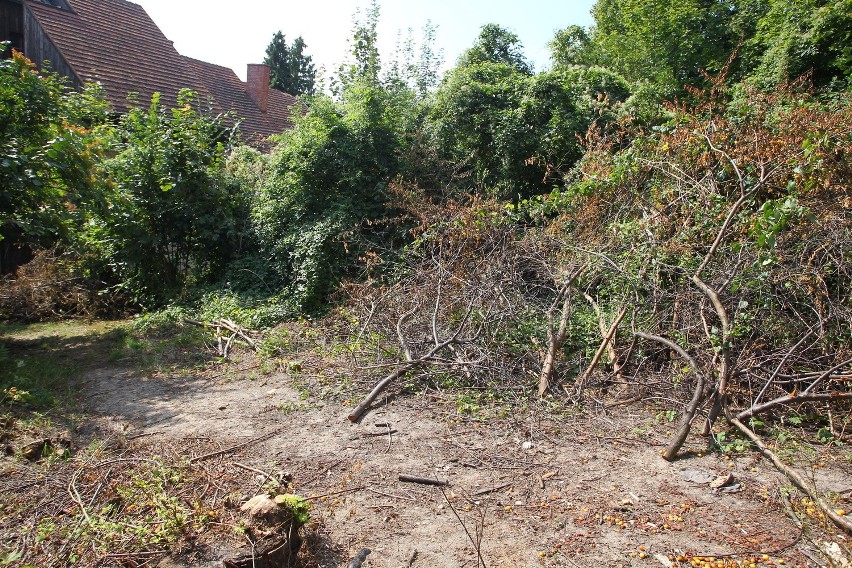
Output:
[{"xmin": 86, "ymin": 91, "xmax": 248, "ymax": 305}]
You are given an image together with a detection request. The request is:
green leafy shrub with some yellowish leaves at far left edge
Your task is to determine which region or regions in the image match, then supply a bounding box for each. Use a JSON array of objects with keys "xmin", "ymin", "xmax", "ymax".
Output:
[{"xmin": 0, "ymin": 52, "xmax": 104, "ymax": 250}]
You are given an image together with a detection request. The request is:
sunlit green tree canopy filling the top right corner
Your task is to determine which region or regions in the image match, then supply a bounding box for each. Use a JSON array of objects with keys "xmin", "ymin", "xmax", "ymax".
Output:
[{"xmin": 550, "ymin": 0, "xmax": 852, "ymax": 103}]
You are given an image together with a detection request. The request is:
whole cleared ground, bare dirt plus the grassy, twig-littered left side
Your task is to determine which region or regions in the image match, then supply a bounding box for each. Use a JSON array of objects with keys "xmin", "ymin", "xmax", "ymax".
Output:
[{"xmin": 0, "ymin": 318, "xmax": 852, "ymax": 567}]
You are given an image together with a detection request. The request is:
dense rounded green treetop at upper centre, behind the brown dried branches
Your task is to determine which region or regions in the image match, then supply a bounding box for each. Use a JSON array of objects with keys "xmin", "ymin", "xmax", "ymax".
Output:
[{"xmin": 429, "ymin": 62, "xmax": 629, "ymax": 199}]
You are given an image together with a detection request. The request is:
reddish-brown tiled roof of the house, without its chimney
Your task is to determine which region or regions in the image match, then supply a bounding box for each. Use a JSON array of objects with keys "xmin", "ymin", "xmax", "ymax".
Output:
[{"xmin": 27, "ymin": 0, "xmax": 301, "ymax": 143}]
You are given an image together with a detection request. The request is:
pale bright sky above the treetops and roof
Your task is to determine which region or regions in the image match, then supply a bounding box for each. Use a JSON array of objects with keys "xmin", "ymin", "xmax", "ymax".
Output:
[{"xmin": 133, "ymin": 0, "xmax": 594, "ymax": 80}]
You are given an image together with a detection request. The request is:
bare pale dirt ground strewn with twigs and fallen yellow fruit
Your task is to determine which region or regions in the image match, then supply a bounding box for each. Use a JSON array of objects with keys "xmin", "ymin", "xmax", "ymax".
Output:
[{"xmin": 5, "ymin": 324, "xmax": 852, "ymax": 568}]
